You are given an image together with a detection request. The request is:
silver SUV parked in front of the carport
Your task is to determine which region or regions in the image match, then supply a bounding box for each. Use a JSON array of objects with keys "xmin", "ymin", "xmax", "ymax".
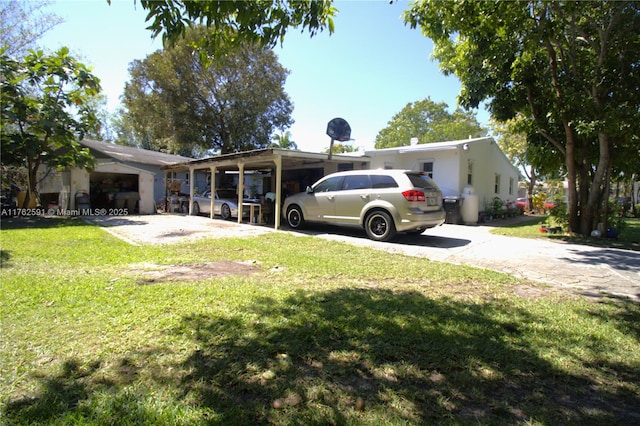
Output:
[{"xmin": 282, "ymin": 169, "xmax": 446, "ymax": 241}]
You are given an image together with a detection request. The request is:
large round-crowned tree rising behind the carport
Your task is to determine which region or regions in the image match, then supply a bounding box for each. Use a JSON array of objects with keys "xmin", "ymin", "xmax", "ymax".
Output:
[{"xmin": 123, "ymin": 28, "xmax": 293, "ymax": 156}]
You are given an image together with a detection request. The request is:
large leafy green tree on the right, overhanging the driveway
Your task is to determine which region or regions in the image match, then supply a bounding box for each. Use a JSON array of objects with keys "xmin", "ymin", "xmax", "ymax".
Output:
[{"xmin": 405, "ymin": 1, "xmax": 640, "ymax": 235}]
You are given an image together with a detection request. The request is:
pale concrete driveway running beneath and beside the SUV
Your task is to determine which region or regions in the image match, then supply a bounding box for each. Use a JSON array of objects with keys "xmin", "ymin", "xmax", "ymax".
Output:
[{"xmin": 87, "ymin": 214, "xmax": 640, "ymax": 302}]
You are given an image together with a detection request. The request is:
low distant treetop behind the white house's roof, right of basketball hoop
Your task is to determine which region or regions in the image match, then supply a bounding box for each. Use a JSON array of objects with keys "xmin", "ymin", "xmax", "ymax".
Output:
[{"xmin": 375, "ymin": 98, "xmax": 486, "ymax": 148}]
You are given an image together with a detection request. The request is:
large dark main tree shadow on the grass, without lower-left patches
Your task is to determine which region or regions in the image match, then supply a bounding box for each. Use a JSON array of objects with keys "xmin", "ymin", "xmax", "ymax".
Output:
[{"xmin": 174, "ymin": 290, "xmax": 640, "ymax": 424}]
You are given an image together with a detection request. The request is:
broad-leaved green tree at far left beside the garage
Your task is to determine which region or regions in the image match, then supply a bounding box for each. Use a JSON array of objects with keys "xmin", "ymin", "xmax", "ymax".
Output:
[{"xmin": 0, "ymin": 48, "xmax": 101, "ymax": 206}]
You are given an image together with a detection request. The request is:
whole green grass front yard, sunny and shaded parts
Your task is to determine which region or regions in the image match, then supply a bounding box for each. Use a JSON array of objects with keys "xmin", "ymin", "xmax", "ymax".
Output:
[{"xmin": 0, "ymin": 218, "xmax": 640, "ymax": 425}]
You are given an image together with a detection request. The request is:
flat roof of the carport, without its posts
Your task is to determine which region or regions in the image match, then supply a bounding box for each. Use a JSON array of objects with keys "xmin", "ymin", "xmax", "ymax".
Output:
[{"xmin": 162, "ymin": 148, "xmax": 370, "ymax": 170}]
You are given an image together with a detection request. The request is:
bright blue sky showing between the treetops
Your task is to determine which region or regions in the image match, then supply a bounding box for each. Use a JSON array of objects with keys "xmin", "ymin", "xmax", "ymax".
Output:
[{"xmin": 40, "ymin": 0, "xmax": 487, "ymax": 152}]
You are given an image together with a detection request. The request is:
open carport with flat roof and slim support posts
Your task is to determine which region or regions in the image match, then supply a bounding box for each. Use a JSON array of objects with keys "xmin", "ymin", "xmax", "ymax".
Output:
[{"xmin": 163, "ymin": 148, "xmax": 369, "ymax": 229}]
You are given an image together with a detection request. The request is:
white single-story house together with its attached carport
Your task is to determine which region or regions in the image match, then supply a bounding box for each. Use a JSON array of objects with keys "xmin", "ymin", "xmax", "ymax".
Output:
[{"xmin": 163, "ymin": 137, "xmax": 519, "ymax": 228}]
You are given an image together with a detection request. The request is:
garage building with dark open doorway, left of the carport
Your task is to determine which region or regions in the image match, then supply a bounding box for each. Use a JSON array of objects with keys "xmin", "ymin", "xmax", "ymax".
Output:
[{"xmin": 38, "ymin": 139, "xmax": 193, "ymax": 214}]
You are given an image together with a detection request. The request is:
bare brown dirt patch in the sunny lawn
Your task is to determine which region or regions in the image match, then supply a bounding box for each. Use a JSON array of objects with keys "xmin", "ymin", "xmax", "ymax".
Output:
[{"xmin": 129, "ymin": 260, "xmax": 261, "ymax": 285}]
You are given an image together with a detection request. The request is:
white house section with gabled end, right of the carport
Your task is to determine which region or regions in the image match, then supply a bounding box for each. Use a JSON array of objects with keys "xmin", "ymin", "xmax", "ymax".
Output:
[{"xmin": 365, "ymin": 137, "xmax": 520, "ymax": 222}]
